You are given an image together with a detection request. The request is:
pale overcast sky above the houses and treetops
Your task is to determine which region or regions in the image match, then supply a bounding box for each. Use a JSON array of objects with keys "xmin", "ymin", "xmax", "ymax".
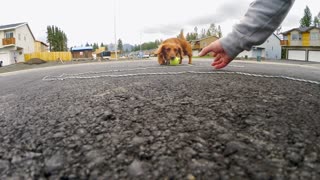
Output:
[{"xmin": 0, "ymin": 0, "xmax": 320, "ymax": 46}]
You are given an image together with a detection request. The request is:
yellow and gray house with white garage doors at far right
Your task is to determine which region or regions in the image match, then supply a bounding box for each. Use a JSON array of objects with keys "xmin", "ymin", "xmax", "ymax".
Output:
[{"xmin": 281, "ymin": 27, "xmax": 320, "ymax": 62}]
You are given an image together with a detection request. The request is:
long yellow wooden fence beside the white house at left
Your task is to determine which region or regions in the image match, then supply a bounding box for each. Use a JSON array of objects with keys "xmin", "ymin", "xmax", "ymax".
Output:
[{"xmin": 24, "ymin": 52, "xmax": 72, "ymax": 62}]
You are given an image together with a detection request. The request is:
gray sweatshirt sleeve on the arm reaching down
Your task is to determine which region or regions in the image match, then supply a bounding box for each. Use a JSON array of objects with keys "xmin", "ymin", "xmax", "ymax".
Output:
[{"xmin": 220, "ymin": 0, "xmax": 294, "ymax": 58}]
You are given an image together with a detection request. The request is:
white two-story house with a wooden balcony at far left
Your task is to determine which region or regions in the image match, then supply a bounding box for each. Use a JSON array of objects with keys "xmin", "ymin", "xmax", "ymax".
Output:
[{"xmin": 0, "ymin": 23, "xmax": 35, "ymax": 66}]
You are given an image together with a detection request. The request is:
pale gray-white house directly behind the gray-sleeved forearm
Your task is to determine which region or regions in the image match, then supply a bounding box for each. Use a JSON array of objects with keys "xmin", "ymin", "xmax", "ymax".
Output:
[{"xmin": 238, "ymin": 34, "xmax": 281, "ymax": 59}]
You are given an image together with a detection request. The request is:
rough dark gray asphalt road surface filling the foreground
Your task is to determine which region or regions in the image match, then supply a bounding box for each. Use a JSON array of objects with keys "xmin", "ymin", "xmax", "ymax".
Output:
[{"xmin": 0, "ymin": 59, "xmax": 320, "ymax": 180}]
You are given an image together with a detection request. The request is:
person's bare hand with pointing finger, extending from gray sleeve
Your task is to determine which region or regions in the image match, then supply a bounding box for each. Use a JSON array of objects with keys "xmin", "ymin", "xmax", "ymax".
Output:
[{"xmin": 199, "ymin": 40, "xmax": 233, "ymax": 69}]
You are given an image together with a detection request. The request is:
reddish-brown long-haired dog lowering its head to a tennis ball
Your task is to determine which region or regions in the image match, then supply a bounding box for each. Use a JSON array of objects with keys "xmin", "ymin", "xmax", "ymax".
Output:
[{"xmin": 155, "ymin": 31, "xmax": 192, "ymax": 65}]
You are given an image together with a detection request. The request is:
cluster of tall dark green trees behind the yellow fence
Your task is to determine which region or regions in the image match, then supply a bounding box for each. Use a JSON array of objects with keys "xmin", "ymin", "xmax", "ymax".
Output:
[{"xmin": 47, "ymin": 26, "xmax": 68, "ymax": 52}]
